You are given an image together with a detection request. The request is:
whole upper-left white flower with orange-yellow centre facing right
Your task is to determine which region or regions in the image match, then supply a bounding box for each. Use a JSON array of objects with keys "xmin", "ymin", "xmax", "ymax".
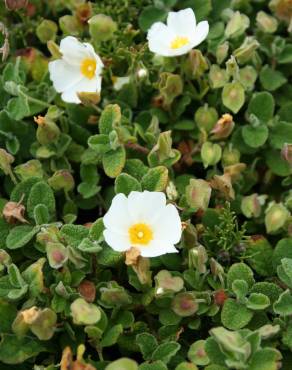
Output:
[{"xmin": 49, "ymin": 36, "xmax": 103, "ymax": 103}]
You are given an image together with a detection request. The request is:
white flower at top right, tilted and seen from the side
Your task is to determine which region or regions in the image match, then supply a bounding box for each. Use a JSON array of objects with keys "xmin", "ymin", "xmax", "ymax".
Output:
[{"xmin": 147, "ymin": 8, "xmax": 209, "ymax": 57}]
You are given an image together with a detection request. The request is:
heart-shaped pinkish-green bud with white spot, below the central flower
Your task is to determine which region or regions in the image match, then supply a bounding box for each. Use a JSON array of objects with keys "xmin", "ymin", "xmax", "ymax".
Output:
[{"xmin": 154, "ymin": 270, "xmax": 184, "ymax": 296}]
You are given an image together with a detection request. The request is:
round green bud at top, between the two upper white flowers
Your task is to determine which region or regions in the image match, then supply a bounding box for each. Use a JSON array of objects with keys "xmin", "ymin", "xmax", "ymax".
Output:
[{"xmin": 88, "ymin": 14, "xmax": 117, "ymax": 42}]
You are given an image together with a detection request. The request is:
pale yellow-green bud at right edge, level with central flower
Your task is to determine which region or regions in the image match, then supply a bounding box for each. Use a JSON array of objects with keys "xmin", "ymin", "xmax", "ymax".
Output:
[{"xmin": 265, "ymin": 202, "xmax": 290, "ymax": 234}]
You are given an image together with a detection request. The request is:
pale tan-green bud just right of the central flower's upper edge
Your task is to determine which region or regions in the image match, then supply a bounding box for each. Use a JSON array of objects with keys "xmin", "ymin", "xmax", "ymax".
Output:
[{"xmin": 186, "ymin": 179, "xmax": 212, "ymax": 211}]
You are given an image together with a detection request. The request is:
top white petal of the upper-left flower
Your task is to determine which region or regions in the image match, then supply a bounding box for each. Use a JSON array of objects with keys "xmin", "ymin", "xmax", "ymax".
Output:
[{"xmin": 60, "ymin": 36, "xmax": 90, "ymax": 65}]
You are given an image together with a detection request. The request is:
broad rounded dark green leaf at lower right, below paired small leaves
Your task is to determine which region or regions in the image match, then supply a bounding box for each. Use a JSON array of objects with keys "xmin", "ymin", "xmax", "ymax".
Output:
[{"xmin": 221, "ymin": 298, "xmax": 253, "ymax": 330}]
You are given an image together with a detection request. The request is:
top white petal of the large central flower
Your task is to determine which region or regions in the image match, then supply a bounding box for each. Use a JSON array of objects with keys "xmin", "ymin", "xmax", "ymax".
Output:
[{"xmin": 128, "ymin": 191, "xmax": 166, "ymax": 225}]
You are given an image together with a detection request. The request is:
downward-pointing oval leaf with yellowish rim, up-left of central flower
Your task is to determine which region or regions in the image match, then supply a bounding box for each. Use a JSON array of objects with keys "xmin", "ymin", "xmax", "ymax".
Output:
[{"xmin": 102, "ymin": 146, "xmax": 126, "ymax": 178}]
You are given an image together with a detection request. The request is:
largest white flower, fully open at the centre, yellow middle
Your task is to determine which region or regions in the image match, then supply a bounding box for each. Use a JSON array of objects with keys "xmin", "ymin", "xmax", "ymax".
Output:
[{"xmin": 103, "ymin": 191, "xmax": 182, "ymax": 257}]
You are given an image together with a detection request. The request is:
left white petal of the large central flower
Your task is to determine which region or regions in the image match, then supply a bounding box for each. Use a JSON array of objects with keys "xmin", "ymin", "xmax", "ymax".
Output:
[{"xmin": 103, "ymin": 193, "xmax": 131, "ymax": 234}]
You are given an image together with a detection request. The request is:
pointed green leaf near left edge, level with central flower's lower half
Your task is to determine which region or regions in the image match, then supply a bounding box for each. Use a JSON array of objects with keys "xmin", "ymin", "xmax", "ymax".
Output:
[{"xmin": 6, "ymin": 225, "xmax": 39, "ymax": 249}]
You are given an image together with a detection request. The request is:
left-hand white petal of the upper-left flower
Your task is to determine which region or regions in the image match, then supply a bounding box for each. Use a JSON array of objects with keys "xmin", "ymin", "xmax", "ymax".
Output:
[{"xmin": 49, "ymin": 59, "xmax": 82, "ymax": 92}]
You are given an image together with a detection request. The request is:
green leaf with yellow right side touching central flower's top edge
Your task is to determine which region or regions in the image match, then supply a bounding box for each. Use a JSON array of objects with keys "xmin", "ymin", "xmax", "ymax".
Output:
[{"xmin": 141, "ymin": 166, "xmax": 168, "ymax": 191}]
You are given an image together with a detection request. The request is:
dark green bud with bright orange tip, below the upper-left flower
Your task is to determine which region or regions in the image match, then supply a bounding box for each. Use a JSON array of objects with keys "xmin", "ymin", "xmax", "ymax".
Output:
[{"xmin": 34, "ymin": 115, "xmax": 60, "ymax": 145}]
